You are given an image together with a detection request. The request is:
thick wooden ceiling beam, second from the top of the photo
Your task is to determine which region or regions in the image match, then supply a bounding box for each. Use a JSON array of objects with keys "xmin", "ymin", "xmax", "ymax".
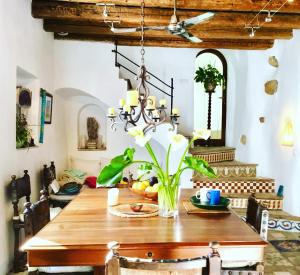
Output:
[{"xmin": 32, "ymin": 0, "xmax": 300, "ymax": 29}]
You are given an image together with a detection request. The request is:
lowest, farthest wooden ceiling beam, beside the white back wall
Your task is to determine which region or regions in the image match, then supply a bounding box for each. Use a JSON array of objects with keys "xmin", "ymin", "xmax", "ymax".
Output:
[{"xmin": 54, "ymin": 33, "xmax": 274, "ymax": 50}]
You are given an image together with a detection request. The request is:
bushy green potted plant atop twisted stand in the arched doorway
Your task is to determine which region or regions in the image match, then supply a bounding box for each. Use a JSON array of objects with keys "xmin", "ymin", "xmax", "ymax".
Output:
[{"xmin": 194, "ymin": 64, "xmax": 225, "ymax": 92}]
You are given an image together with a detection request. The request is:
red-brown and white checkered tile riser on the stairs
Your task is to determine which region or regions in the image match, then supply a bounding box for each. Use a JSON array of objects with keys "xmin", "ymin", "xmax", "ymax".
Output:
[{"xmin": 193, "ymin": 178, "xmax": 275, "ymax": 193}]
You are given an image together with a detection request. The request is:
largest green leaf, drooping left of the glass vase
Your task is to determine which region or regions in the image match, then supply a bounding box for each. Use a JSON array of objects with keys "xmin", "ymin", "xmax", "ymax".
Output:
[{"xmin": 97, "ymin": 148, "xmax": 135, "ymax": 187}]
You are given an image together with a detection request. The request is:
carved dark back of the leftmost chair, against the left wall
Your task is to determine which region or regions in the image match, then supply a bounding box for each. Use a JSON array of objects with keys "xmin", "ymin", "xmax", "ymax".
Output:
[{"xmin": 10, "ymin": 170, "xmax": 31, "ymax": 219}]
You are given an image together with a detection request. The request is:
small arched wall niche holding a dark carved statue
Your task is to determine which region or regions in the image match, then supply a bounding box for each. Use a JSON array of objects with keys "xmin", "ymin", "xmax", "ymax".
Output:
[{"xmin": 77, "ymin": 104, "xmax": 107, "ymax": 151}]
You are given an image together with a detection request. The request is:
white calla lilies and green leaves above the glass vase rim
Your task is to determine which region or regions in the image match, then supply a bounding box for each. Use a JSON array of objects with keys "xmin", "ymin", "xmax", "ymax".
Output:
[{"xmin": 97, "ymin": 127, "xmax": 216, "ymax": 190}]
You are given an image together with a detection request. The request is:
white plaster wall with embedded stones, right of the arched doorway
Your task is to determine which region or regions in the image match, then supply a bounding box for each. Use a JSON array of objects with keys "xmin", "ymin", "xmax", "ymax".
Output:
[{"xmin": 227, "ymin": 31, "xmax": 300, "ymax": 216}]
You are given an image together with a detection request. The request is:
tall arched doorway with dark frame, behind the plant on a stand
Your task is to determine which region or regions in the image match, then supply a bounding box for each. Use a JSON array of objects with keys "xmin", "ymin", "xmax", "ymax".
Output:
[{"xmin": 194, "ymin": 49, "xmax": 227, "ymax": 146}]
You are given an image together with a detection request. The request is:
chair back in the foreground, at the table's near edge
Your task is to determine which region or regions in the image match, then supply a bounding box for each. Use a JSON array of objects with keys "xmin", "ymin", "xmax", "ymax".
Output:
[{"xmin": 105, "ymin": 242, "xmax": 221, "ymax": 275}]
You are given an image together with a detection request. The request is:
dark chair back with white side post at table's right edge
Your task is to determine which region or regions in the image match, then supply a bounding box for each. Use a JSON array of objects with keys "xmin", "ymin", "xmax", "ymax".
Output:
[{"xmin": 246, "ymin": 193, "xmax": 269, "ymax": 241}]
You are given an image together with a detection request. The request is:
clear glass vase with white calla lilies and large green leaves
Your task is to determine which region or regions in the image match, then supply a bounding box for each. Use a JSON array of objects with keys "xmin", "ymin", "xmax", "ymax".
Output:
[{"xmin": 97, "ymin": 127, "xmax": 215, "ymax": 217}]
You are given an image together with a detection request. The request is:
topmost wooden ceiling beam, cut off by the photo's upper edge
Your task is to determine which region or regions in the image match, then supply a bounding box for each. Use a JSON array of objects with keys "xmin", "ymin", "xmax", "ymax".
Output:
[{"xmin": 41, "ymin": 0, "xmax": 300, "ymax": 13}]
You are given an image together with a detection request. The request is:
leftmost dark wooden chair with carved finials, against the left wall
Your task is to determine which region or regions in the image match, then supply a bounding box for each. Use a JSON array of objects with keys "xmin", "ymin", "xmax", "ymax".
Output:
[{"xmin": 9, "ymin": 170, "xmax": 31, "ymax": 272}]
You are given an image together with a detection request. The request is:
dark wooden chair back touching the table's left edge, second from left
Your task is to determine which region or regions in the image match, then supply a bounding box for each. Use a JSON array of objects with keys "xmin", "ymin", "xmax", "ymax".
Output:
[{"xmin": 24, "ymin": 190, "xmax": 50, "ymax": 239}]
